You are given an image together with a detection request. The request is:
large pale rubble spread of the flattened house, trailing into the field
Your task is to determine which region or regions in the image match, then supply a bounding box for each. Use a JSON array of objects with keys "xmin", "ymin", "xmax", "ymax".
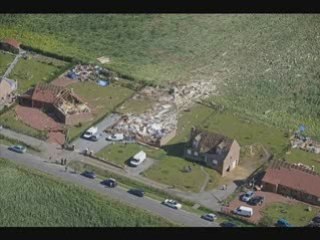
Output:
[{"xmin": 107, "ymin": 81, "xmax": 216, "ymax": 143}]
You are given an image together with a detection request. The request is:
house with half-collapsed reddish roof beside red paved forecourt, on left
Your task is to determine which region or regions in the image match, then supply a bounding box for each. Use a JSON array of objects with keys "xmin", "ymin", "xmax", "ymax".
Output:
[{"xmin": 19, "ymin": 83, "xmax": 92, "ymax": 126}]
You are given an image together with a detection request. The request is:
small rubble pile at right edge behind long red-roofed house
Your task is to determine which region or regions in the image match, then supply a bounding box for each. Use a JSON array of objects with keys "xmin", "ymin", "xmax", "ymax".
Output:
[{"xmin": 290, "ymin": 134, "xmax": 320, "ymax": 154}]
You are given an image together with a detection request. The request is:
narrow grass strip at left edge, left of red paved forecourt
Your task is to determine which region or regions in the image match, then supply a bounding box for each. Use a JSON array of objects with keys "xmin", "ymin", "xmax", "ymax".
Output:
[{"xmin": 0, "ymin": 108, "xmax": 47, "ymax": 139}]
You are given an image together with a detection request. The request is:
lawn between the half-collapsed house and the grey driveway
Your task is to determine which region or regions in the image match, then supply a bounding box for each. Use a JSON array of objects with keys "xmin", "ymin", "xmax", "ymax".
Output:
[{"xmin": 69, "ymin": 82, "xmax": 134, "ymax": 140}]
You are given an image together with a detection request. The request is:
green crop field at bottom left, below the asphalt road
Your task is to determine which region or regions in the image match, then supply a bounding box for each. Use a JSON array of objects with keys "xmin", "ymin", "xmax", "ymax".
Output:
[{"xmin": 0, "ymin": 159, "xmax": 173, "ymax": 227}]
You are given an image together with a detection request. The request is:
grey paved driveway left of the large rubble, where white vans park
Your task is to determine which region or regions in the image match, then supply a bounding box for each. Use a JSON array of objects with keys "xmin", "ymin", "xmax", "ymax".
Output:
[{"xmin": 71, "ymin": 114, "xmax": 121, "ymax": 153}]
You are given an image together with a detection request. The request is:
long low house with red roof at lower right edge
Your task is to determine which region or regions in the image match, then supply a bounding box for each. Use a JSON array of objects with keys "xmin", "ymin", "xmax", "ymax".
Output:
[{"xmin": 262, "ymin": 161, "xmax": 320, "ymax": 205}]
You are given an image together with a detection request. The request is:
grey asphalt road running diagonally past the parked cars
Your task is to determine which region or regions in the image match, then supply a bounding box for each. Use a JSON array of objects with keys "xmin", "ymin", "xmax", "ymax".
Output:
[{"xmin": 0, "ymin": 145, "xmax": 219, "ymax": 227}]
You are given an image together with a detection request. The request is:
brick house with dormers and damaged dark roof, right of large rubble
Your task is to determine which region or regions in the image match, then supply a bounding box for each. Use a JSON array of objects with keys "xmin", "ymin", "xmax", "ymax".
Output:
[{"xmin": 184, "ymin": 128, "xmax": 240, "ymax": 176}]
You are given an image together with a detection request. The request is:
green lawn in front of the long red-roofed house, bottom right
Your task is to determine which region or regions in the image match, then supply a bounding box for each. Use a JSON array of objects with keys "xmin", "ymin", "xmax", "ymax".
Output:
[{"xmin": 261, "ymin": 203, "xmax": 319, "ymax": 227}]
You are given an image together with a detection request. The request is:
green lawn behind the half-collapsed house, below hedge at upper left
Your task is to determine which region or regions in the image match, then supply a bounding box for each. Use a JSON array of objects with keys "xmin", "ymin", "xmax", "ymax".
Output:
[{"xmin": 9, "ymin": 55, "xmax": 63, "ymax": 93}]
